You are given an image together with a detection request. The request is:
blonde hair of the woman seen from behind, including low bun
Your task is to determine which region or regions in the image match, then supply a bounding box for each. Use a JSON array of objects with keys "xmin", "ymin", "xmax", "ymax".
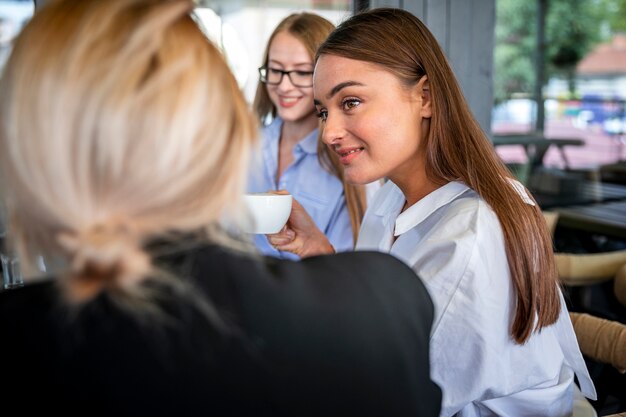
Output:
[{"xmin": 0, "ymin": 0, "xmax": 257, "ymax": 303}]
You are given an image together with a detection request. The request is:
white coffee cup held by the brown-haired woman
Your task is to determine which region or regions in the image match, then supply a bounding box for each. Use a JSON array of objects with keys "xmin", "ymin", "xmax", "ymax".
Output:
[{"xmin": 244, "ymin": 193, "xmax": 292, "ymax": 234}]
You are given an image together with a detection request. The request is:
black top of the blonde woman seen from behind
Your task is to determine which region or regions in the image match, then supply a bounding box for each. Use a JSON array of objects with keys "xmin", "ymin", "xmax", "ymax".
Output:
[{"xmin": 0, "ymin": 246, "xmax": 441, "ymax": 417}]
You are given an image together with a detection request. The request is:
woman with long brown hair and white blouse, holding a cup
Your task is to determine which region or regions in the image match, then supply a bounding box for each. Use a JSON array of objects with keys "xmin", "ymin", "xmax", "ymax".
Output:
[{"xmin": 270, "ymin": 8, "xmax": 595, "ymax": 416}]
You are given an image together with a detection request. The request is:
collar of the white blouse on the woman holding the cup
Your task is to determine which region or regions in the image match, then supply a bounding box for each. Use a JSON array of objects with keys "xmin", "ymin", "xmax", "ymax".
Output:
[{"xmin": 394, "ymin": 181, "xmax": 470, "ymax": 236}]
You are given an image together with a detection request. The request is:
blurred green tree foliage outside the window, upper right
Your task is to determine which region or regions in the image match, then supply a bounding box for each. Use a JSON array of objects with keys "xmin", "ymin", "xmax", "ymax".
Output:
[{"xmin": 494, "ymin": 0, "xmax": 604, "ymax": 103}]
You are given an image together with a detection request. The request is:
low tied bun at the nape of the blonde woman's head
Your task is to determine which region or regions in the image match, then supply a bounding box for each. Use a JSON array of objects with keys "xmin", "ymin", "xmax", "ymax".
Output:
[{"xmin": 57, "ymin": 223, "xmax": 150, "ymax": 302}]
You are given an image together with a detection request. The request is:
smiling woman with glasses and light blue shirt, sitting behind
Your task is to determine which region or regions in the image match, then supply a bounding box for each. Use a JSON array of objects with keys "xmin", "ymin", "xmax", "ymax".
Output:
[{"xmin": 248, "ymin": 13, "xmax": 365, "ymax": 259}]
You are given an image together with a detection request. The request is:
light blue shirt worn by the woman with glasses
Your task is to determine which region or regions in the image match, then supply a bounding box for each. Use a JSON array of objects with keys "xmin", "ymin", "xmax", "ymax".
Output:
[{"xmin": 248, "ymin": 117, "xmax": 354, "ymax": 259}]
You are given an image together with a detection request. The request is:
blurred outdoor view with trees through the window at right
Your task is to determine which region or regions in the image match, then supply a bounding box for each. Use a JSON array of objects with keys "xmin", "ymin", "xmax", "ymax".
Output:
[{"xmin": 491, "ymin": 0, "xmax": 626, "ymax": 168}]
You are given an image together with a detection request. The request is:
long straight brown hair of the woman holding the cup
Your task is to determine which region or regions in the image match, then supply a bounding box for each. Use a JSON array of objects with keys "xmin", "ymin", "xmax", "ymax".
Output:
[{"xmin": 316, "ymin": 8, "xmax": 560, "ymax": 344}]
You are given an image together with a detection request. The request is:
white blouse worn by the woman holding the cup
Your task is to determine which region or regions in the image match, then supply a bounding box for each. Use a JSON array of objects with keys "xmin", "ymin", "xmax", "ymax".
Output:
[{"xmin": 357, "ymin": 181, "xmax": 596, "ymax": 417}]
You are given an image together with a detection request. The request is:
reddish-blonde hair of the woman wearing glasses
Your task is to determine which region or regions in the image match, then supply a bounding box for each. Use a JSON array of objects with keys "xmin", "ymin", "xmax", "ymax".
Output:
[{"xmin": 253, "ymin": 12, "xmax": 366, "ymax": 243}]
